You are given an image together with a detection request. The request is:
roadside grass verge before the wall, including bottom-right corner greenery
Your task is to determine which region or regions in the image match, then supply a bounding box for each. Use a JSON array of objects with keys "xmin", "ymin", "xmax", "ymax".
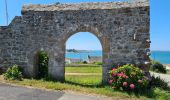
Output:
[{"xmin": 4, "ymin": 79, "xmax": 170, "ymax": 100}]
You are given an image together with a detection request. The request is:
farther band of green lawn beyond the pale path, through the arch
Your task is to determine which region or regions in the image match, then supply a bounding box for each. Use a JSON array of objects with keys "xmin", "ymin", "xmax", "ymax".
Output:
[{"xmin": 65, "ymin": 66, "xmax": 102, "ymax": 73}]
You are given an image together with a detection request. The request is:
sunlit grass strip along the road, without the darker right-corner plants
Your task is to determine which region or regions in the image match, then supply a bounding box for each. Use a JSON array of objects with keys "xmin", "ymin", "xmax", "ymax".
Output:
[{"xmin": 8, "ymin": 79, "xmax": 149, "ymax": 100}]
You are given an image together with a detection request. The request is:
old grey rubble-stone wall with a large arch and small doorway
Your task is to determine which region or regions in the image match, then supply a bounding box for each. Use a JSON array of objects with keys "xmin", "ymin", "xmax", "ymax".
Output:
[{"xmin": 0, "ymin": 2, "xmax": 150, "ymax": 81}]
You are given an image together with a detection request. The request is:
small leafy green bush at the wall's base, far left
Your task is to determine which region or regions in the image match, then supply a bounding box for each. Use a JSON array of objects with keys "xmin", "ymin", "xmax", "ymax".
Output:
[{"xmin": 3, "ymin": 65, "xmax": 22, "ymax": 80}]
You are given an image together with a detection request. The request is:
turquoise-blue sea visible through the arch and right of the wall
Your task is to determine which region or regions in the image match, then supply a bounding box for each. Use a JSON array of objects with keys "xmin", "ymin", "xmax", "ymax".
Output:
[{"xmin": 65, "ymin": 50, "xmax": 170, "ymax": 64}]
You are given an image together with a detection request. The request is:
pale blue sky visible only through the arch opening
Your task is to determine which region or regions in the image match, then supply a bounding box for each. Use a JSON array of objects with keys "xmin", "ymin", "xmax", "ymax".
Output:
[{"xmin": 66, "ymin": 32, "xmax": 102, "ymax": 50}]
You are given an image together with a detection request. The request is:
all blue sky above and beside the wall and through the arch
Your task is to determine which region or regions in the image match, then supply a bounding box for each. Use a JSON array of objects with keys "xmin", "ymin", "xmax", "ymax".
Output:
[{"xmin": 0, "ymin": 0, "xmax": 170, "ymax": 51}]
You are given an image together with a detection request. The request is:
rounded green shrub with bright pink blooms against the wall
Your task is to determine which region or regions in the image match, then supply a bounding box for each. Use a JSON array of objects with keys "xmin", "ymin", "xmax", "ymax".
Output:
[{"xmin": 108, "ymin": 64, "xmax": 149, "ymax": 91}]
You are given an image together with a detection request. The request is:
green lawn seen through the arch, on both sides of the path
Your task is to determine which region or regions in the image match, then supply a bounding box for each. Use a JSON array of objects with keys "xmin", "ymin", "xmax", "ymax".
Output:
[{"xmin": 65, "ymin": 65, "xmax": 102, "ymax": 86}]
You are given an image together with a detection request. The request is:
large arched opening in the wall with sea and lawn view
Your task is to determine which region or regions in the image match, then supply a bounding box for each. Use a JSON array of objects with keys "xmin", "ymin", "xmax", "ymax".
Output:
[{"xmin": 65, "ymin": 32, "xmax": 103, "ymax": 86}]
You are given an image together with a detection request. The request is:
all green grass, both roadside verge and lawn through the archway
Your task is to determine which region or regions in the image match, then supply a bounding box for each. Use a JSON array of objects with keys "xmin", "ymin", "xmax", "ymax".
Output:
[{"xmin": 1, "ymin": 66, "xmax": 170, "ymax": 100}]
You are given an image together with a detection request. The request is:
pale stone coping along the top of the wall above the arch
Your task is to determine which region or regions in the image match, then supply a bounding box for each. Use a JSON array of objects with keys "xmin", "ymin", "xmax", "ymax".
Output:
[{"xmin": 22, "ymin": 2, "xmax": 149, "ymax": 11}]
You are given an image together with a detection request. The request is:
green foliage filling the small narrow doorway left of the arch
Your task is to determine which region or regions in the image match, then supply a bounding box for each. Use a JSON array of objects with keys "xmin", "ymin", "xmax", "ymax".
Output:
[{"xmin": 38, "ymin": 51, "xmax": 49, "ymax": 78}]
